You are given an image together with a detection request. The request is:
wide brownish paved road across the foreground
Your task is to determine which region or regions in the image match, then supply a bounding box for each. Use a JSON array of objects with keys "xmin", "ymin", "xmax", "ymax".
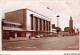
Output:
[{"xmin": 2, "ymin": 36, "xmax": 79, "ymax": 50}]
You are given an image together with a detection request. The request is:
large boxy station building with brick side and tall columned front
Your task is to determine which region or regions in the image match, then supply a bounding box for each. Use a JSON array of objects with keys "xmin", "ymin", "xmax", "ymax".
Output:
[{"xmin": 2, "ymin": 9, "xmax": 51, "ymax": 38}]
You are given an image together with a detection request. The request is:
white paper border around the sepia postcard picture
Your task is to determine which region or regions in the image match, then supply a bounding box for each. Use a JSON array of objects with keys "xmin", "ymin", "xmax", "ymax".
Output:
[{"xmin": 0, "ymin": 0, "xmax": 80, "ymax": 55}]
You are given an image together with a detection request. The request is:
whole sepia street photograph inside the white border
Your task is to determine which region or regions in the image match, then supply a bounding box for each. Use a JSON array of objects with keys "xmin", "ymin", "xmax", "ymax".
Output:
[{"xmin": 0, "ymin": 0, "xmax": 80, "ymax": 51}]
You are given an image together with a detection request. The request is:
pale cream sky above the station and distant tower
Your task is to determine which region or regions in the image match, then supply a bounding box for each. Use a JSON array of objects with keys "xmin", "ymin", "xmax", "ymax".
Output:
[{"xmin": 0, "ymin": 0, "xmax": 79, "ymax": 30}]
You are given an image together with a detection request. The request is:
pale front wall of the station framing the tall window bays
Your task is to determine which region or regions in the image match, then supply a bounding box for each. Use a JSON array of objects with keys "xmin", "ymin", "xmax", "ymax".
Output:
[{"xmin": 26, "ymin": 10, "xmax": 51, "ymax": 31}]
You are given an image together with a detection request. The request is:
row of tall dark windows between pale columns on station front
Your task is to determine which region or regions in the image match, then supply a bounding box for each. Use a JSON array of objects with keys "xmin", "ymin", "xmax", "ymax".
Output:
[{"xmin": 30, "ymin": 14, "xmax": 50, "ymax": 31}]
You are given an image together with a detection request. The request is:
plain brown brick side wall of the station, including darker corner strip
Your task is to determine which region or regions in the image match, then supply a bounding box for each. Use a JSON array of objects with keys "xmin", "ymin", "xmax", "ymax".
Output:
[{"xmin": 5, "ymin": 9, "xmax": 26, "ymax": 30}]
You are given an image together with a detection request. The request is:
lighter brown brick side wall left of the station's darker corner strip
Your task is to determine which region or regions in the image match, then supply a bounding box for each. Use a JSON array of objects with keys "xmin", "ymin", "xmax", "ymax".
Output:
[{"xmin": 5, "ymin": 10, "xmax": 23, "ymax": 23}]
